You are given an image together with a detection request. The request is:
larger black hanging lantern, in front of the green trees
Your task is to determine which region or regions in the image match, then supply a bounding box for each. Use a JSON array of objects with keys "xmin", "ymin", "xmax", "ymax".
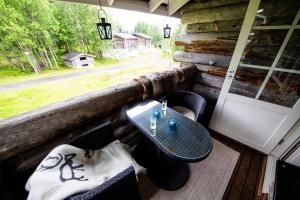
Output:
[{"xmin": 97, "ymin": 0, "xmax": 112, "ymax": 40}]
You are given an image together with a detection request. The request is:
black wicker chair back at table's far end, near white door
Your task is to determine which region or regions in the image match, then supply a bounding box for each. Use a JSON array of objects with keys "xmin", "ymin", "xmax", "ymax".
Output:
[{"xmin": 161, "ymin": 91, "xmax": 206, "ymax": 122}]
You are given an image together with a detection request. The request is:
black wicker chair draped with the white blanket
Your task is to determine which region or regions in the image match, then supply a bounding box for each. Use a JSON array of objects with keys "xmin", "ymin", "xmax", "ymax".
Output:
[{"xmin": 68, "ymin": 122, "xmax": 141, "ymax": 200}]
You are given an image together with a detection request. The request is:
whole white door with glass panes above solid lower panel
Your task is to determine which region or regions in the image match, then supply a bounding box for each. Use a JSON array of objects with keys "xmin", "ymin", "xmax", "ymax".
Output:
[{"xmin": 210, "ymin": 0, "xmax": 300, "ymax": 153}]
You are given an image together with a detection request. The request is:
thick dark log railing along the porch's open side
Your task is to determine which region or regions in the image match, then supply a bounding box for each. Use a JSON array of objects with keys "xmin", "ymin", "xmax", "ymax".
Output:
[{"xmin": 0, "ymin": 66, "xmax": 197, "ymax": 172}]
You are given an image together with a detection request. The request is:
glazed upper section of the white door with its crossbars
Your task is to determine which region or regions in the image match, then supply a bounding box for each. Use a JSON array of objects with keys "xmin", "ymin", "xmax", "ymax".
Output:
[{"xmin": 229, "ymin": 1, "xmax": 300, "ymax": 108}]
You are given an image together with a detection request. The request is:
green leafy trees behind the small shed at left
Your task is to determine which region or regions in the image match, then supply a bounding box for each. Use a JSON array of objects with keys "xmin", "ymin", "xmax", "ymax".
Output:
[{"xmin": 0, "ymin": 0, "xmax": 120, "ymax": 73}]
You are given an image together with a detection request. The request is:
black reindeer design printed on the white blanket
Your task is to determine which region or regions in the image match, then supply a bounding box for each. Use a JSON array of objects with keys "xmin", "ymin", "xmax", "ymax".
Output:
[{"xmin": 36, "ymin": 153, "xmax": 89, "ymax": 182}]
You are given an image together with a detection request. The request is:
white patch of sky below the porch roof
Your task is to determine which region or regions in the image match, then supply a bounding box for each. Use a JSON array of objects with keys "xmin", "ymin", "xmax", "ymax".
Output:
[{"xmin": 105, "ymin": 8, "xmax": 180, "ymax": 32}]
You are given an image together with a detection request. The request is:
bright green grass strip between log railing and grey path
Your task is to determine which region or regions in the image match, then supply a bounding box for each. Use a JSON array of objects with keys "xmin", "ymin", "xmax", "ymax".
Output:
[{"xmin": 0, "ymin": 66, "xmax": 162, "ymax": 119}]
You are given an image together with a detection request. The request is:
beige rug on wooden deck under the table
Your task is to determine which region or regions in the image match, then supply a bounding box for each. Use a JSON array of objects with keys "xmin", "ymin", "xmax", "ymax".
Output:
[{"xmin": 139, "ymin": 140, "xmax": 239, "ymax": 200}]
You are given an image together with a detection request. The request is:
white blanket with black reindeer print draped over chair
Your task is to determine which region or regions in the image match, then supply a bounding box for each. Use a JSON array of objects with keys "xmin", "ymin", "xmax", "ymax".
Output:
[{"xmin": 25, "ymin": 140, "xmax": 143, "ymax": 200}]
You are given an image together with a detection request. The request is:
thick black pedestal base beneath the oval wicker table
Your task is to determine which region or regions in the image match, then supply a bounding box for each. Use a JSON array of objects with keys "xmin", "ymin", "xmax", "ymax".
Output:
[{"xmin": 135, "ymin": 139, "xmax": 189, "ymax": 190}]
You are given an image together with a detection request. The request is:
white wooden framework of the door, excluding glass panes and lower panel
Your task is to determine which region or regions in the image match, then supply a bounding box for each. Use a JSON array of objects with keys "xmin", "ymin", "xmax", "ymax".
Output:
[{"xmin": 209, "ymin": 0, "xmax": 300, "ymax": 153}]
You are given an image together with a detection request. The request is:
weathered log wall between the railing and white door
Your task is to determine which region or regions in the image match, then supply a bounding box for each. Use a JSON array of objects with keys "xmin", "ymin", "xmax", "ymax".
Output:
[{"xmin": 173, "ymin": 0, "xmax": 248, "ymax": 113}]
